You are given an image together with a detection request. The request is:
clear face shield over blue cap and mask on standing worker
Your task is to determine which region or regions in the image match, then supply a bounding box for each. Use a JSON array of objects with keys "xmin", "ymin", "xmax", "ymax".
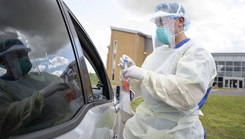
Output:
[{"xmin": 151, "ymin": 2, "xmax": 190, "ymax": 49}]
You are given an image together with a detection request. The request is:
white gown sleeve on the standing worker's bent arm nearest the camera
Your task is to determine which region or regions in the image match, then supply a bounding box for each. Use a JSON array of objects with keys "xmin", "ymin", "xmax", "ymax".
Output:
[{"xmin": 142, "ymin": 49, "xmax": 216, "ymax": 111}]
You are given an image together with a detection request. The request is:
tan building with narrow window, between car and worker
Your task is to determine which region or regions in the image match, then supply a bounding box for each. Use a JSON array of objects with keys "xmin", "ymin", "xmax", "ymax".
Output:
[{"xmin": 106, "ymin": 29, "xmax": 151, "ymax": 83}]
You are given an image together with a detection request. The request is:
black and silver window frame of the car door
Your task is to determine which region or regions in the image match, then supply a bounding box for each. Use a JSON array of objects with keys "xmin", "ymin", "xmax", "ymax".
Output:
[{"xmin": 11, "ymin": 0, "xmax": 118, "ymax": 139}]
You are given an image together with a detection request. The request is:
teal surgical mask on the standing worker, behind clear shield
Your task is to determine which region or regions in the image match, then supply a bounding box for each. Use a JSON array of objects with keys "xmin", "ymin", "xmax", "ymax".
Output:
[{"xmin": 156, "ymin": 27, "xmax": 172, "ymax": 45}]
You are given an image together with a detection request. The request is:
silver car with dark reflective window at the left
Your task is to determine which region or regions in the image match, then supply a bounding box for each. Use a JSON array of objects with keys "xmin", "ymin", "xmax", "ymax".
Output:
[{"xmin": 0, "ymin": 0, "xmax": 120, "ymax": 139}]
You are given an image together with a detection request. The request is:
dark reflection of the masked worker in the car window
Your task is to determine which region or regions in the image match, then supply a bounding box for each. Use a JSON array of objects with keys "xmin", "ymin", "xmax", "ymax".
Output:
[{"xmin": 0, "ymin": 39, "xmax": 72, "ymax": 136}]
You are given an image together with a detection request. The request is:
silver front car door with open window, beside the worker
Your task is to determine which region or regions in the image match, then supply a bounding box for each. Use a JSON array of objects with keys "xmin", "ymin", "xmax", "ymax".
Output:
[{"xmin": 55, "ymin": 2, "xmax": 121, "ymax": 139}]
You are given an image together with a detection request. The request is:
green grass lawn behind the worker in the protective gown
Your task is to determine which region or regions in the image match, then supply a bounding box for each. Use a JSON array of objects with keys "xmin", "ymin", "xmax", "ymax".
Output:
[{"xmin": 131, "ymin": 95, "xmax": 245, "ymax": 139}]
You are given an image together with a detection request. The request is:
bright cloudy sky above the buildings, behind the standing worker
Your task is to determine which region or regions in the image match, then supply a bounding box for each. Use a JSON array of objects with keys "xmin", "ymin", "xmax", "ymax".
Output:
[{"xmin": 64, "ymin": 0, "xmax": 245, "ymax": 63}]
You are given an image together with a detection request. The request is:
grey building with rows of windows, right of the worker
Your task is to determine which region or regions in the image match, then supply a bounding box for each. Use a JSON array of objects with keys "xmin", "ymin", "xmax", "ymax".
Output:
[{"xmin": 212, "ymin": 53, "xmax": 245, "ymax": 89}]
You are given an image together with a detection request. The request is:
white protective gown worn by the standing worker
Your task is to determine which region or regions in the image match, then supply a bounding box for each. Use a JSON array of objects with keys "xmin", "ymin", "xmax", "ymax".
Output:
[{"xmin": 123, "ymin": 40, "xmax": 216, "ymax": 139}]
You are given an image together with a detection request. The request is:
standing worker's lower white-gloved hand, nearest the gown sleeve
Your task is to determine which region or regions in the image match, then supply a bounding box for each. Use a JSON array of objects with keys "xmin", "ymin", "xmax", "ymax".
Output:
[{"xmin": 122, "ymin": 66, "xmax": 145, "ymax": 80}]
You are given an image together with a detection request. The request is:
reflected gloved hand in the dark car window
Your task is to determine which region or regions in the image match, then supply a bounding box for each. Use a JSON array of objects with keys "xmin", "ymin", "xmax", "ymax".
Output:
[{"xmin": 40, "ymin": 81, "xmax": 70, "ymax": 98}]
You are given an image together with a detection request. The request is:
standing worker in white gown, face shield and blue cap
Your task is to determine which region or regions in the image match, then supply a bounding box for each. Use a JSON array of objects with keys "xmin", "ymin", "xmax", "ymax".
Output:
[{"xmin": 119, "ymin": 2, "xmax": 216, "ymax": 139}]
